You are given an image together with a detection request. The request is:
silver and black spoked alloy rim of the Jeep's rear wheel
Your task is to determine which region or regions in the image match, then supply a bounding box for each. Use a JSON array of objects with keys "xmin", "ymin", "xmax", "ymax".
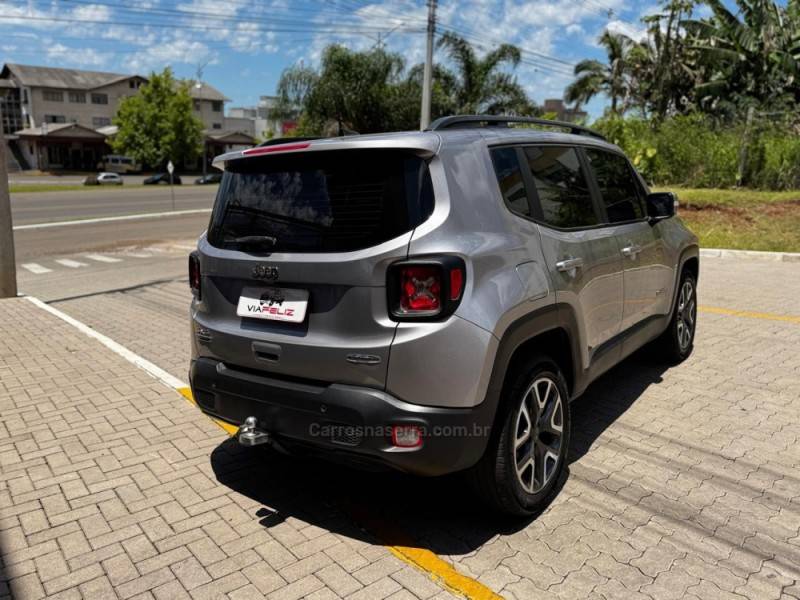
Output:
[{"xmin": 513, "ymin": 376, "xmax": 564, "ymax": 494}]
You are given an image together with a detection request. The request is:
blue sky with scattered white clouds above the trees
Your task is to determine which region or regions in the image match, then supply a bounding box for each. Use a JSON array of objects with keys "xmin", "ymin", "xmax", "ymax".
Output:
[{"xmin": 0, "ymin": 0, "xmax": 708, "ymax": 116}]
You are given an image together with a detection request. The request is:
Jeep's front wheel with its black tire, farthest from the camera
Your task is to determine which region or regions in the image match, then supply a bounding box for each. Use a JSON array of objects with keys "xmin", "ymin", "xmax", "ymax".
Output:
[{"xmin": 653, "ymin": 270, "xmax": 697, "ymax": 364}]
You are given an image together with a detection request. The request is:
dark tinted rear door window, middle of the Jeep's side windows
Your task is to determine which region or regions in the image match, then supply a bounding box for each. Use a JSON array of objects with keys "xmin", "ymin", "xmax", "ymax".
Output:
[{"xmin": 525, "ymin": 146, "xmax": 598, "ymax": 229}]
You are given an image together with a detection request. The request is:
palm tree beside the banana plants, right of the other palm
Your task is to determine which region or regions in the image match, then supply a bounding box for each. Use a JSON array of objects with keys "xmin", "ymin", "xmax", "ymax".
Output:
[{"xmin": 564, "ymin": 30, "xmax": 636, "ymax": 115}]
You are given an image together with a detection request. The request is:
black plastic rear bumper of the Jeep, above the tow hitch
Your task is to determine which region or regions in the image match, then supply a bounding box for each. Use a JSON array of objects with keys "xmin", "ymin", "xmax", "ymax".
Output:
[{"xmin": 190, "ymin": 358, "xmax": 494, "ymax": 476}]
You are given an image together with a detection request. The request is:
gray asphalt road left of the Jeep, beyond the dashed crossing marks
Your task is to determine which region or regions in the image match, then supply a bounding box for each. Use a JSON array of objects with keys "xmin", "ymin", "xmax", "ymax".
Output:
[{"xmin": 11, "ymin": 186, "xmax": 216, "ymax": 265}]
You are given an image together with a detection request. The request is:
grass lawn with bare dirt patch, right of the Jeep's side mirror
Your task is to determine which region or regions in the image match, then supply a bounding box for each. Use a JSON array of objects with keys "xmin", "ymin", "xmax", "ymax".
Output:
[{"xmin": 659, "ymin": 188, "xmax": 800, "ymax": 252}]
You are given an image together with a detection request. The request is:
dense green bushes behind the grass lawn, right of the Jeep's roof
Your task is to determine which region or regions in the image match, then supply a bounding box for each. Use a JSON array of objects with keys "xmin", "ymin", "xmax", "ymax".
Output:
[{"xmin": 594, "ymin": 114, "xmax": 800, "ymax": 190}]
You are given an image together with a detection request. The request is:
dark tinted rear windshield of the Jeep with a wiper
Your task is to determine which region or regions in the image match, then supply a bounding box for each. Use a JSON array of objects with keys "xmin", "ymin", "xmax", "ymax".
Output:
[{"xmin": 208, "ymin": 150, "xmax": 433, "ymax": 252}]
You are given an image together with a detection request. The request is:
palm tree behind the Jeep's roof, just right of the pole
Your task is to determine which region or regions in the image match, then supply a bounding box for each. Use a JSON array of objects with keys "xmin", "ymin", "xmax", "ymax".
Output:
[{"xmin": 434, "ymin": 32, "xmax": 536, "ymax": 114}]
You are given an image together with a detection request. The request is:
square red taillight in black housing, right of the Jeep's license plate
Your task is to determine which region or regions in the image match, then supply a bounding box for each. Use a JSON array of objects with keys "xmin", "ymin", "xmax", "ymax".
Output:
[{"xmin": 387, "ymin": 256, "xmax": 466, "ymax": 321}]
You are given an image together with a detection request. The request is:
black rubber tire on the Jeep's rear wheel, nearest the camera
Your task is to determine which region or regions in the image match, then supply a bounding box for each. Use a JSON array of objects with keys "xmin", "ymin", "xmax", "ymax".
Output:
[{"xmin": 468, "ymin": 356, "xmax": 570, "ymax": 516}]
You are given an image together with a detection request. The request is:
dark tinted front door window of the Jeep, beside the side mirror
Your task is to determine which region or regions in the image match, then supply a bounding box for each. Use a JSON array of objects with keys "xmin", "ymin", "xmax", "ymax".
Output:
[{"xmin": 586, "ymin": 149, "xmax": 644, "ymax": 223}]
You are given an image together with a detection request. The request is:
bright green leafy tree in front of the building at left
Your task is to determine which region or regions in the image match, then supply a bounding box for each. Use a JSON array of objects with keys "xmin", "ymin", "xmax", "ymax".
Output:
[{"xmin": 112, "ymin": 67, "xmax": 203, "ymax": 168}]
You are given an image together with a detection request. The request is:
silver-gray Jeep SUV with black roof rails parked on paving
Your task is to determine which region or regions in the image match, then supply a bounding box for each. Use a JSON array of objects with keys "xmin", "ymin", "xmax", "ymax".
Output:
[{"xmin": 189, "ymin": 116, "xmax": 699, "ymax": 514}]
